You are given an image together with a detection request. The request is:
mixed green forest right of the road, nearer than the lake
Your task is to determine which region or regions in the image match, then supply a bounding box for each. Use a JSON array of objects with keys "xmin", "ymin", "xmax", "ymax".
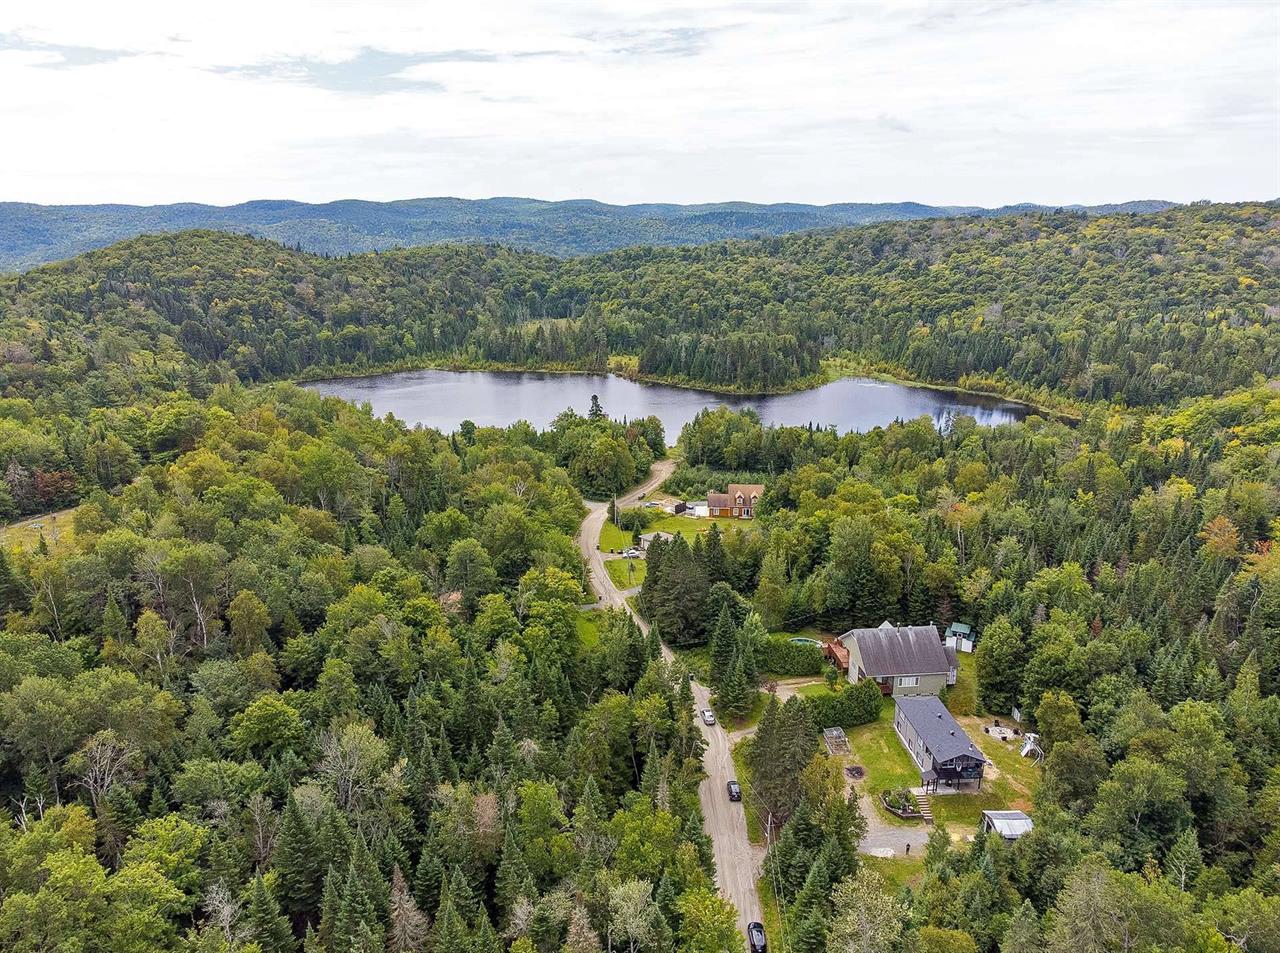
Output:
[{"xmin": 624, "ymin": 386, "xmax": 1280, "ymax": 953}]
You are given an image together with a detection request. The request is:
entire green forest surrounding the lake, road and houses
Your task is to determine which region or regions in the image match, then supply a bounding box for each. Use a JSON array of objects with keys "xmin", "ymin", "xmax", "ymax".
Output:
[{"xmin": 0, "ymin": 205, "xmax": 1280, "ymax": 953}]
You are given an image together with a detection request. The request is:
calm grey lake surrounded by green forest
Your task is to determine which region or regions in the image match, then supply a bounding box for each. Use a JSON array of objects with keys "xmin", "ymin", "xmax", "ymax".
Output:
[{"xmin": 303, "ymin": 371, "xmax": 1028, "ymax": 434}]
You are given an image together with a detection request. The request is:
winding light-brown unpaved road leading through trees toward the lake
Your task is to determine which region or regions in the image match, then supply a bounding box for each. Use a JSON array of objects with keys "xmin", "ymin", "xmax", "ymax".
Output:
[{"xmin": 577, "ymin": 461, "xmax": 764, "ymax": 936}]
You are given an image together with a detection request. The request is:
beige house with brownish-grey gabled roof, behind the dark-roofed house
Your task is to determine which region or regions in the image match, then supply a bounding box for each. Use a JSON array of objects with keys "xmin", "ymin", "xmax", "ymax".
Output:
[{"xmin": 840, "ymin": 622, "xmax": 956, "ymax": 697}]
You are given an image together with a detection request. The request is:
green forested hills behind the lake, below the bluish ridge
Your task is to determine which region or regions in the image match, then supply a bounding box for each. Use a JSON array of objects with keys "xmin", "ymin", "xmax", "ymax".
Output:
[{"xmin": 0, "ymin": 203, "xmax": 1280, "ymax": 408}]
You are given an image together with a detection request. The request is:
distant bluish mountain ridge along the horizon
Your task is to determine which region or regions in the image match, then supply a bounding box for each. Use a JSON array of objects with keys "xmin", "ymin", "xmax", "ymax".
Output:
[{"xmin": 0, "ymin": 198, "xmax": 1176, "ymax": 271}]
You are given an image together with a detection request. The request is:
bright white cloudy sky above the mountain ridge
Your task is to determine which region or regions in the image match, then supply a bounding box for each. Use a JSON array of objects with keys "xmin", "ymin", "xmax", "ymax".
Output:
[{"xmin": 0, "ymin": 0, "xmax": 1280, "ymax": 206}]
